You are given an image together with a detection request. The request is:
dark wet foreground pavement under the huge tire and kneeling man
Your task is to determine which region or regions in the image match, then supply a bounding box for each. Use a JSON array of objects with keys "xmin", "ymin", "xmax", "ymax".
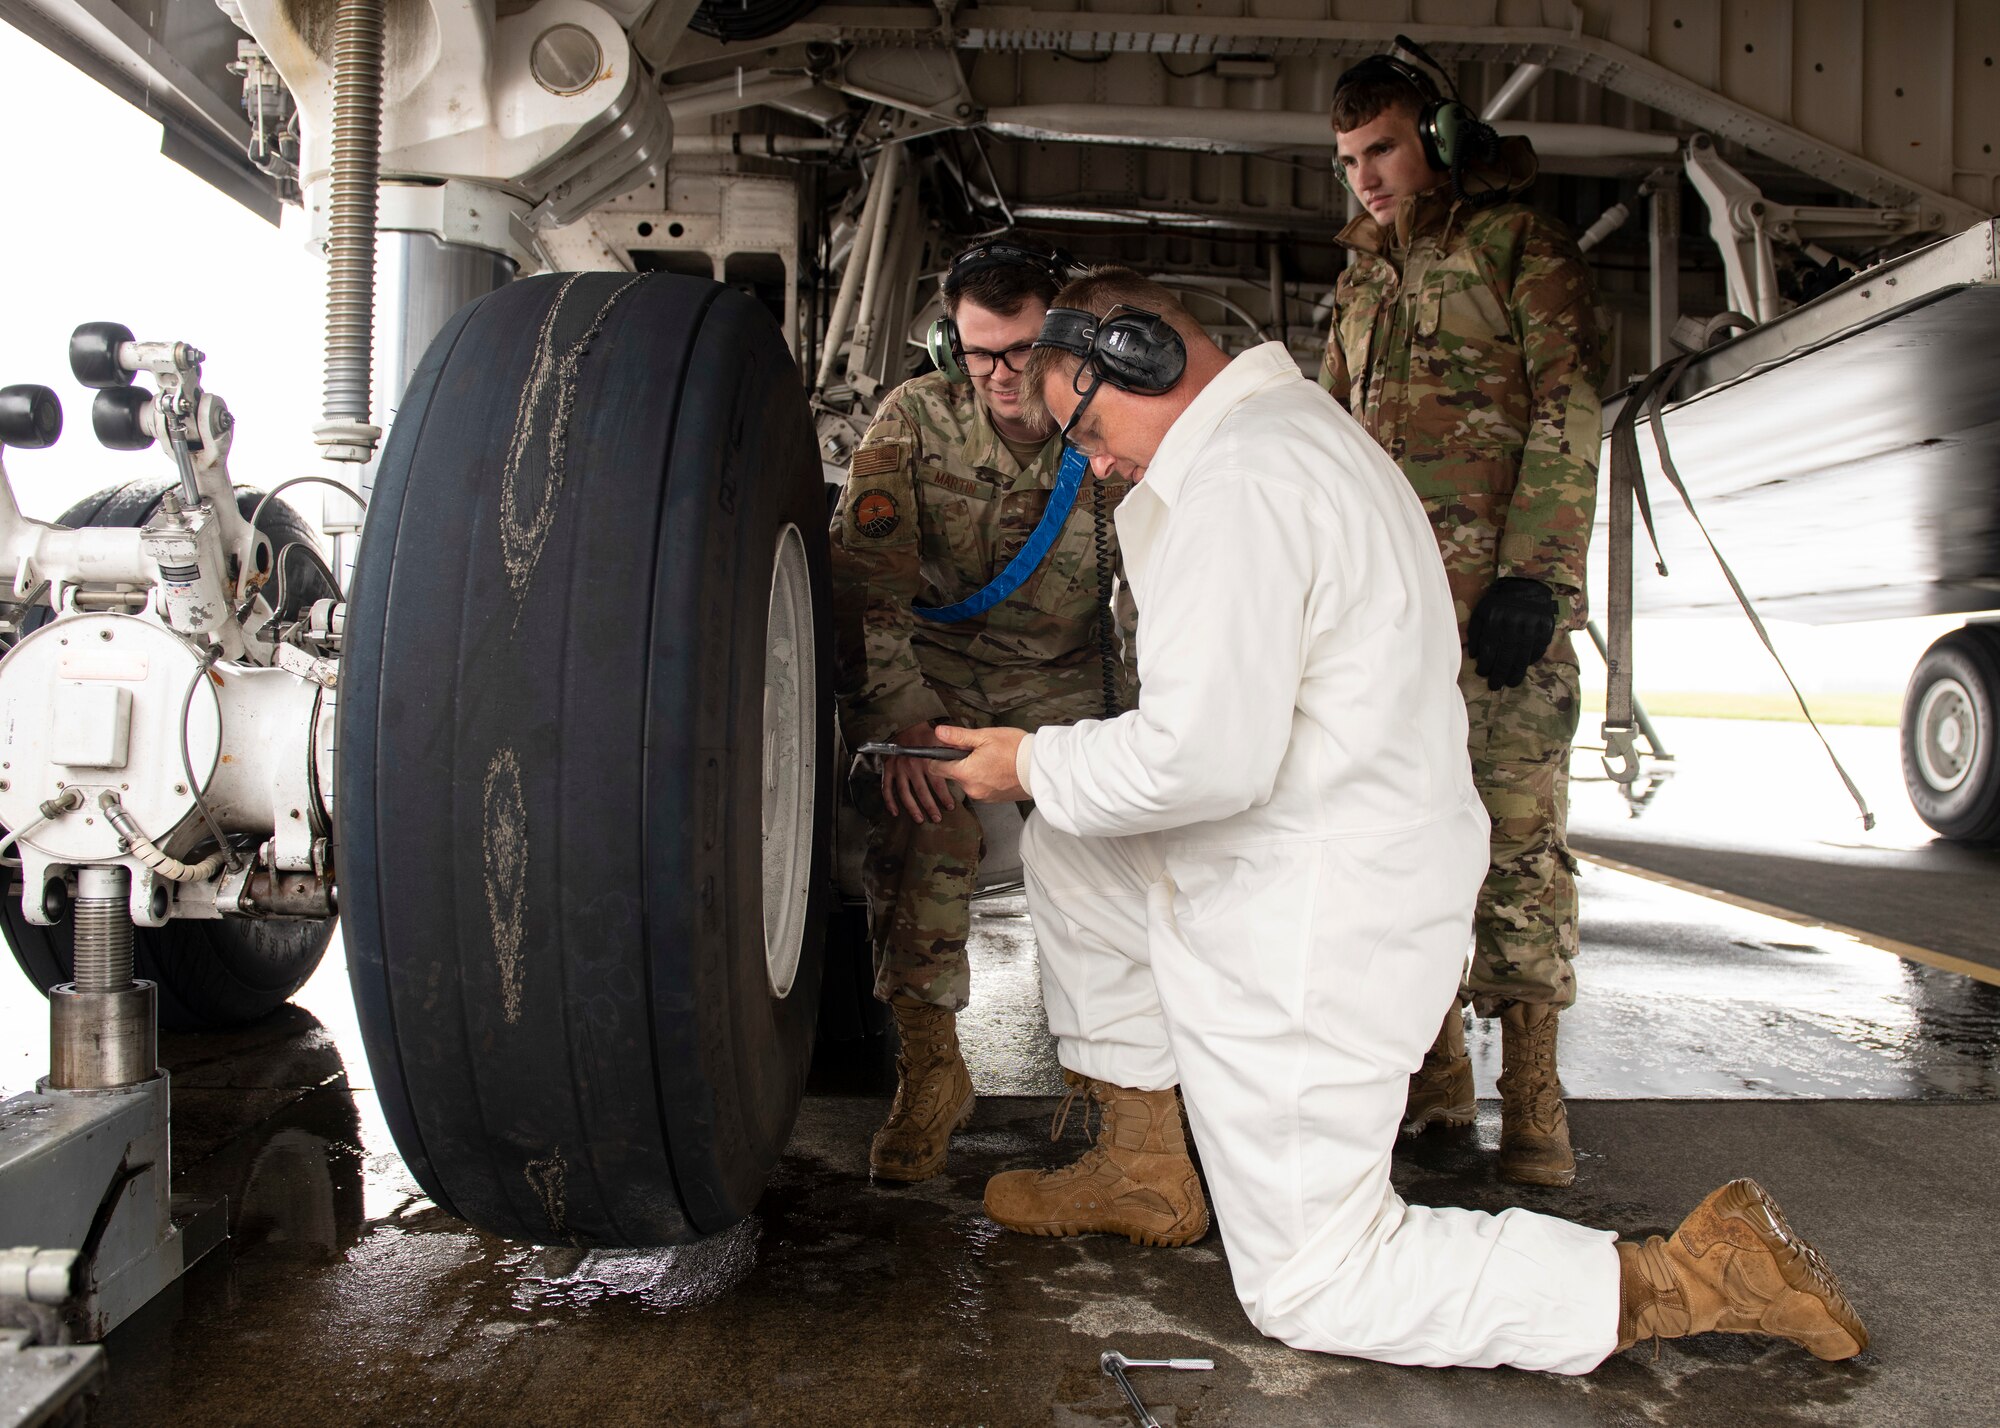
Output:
[{"xmin": 62, "ymin": 1096, "xmax": 2000, "ymax": 1428}]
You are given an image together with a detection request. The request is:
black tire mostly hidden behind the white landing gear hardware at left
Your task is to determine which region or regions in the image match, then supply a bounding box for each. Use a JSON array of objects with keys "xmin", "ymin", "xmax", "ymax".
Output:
[{"xmin": 0, "ymin": 476, "xmax": 334, "ymax": 1032}]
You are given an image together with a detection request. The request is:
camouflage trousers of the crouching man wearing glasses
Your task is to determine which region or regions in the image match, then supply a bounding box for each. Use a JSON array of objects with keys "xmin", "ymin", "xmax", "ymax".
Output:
[{"xmin": 850, "ymin": 664, "xmax": 1104, "ymax": 1012}]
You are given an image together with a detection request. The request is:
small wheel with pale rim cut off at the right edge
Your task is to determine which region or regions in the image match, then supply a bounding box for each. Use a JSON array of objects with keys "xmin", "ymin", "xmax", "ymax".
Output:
[{"xmin": 1902, "ymin": 624, "xmax": 2000, "ymax": 842}]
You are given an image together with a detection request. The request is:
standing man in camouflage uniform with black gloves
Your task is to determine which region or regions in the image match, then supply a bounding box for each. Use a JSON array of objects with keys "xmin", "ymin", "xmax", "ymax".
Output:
[{"xmin": 1320, "ymin": 67, "xmax": 1604, "ymax": 1186}]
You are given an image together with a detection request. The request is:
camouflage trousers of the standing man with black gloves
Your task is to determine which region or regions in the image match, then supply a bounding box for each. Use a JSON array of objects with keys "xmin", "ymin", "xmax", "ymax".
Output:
[{"xmin": 1458, "ymin": 634, "xmax": 1578, "ymax": 1016}]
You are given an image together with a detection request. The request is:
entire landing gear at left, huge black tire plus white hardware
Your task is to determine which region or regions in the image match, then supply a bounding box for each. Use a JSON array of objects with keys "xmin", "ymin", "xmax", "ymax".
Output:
[{"xmin": 0, "ymin": 274, "xmax": 834, "ymax": 1400}]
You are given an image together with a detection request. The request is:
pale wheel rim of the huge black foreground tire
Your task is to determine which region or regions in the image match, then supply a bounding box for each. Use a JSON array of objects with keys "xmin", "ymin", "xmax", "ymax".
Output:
[{"xmin": 764, "ymin": 526, "xmax": 818, "ymax": 998}]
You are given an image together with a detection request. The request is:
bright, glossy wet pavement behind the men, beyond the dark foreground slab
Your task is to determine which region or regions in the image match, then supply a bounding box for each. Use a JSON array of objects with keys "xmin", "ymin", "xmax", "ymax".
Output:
[{"xmin": 944, "ymin": 880, "xmax": 2000, "ymax": 1100}]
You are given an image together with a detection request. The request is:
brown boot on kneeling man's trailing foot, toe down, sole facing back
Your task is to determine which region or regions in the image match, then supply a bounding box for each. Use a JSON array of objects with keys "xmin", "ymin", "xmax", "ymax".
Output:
[{"xmin": 1618, "ymin": 1180, "xmax": 1868, "ymax": 1358}]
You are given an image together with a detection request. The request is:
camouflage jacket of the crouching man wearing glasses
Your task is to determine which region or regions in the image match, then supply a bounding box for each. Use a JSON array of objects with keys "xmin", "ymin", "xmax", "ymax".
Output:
[{"xmin": 832, "ymin": 374, "xmax": 1132, "ymax": 748}]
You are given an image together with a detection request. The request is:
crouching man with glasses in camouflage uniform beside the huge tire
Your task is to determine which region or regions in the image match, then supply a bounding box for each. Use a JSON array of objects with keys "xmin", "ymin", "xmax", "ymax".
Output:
[{"xmin": 832, "ymin": 242, "xmax": 1136, "ymax": 1180}]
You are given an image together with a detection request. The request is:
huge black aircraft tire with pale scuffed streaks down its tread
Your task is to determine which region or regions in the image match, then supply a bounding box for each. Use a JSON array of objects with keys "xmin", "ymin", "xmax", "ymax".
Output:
[{"xmin": 336, "ymin": 272, "xmax": 834, "ymax": 1246}]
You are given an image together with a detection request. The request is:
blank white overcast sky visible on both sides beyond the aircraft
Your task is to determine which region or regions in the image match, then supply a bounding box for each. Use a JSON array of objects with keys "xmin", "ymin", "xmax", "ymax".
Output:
[{"xmin": 0, "ymin": 11, "xmax": 1956, "ymax": 692}]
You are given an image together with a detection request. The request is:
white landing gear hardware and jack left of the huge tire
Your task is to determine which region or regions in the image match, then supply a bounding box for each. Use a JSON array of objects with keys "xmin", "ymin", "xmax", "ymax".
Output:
[{"xmin": 0, "ymin": 324, "xmax": 328, "ymax": 1340}]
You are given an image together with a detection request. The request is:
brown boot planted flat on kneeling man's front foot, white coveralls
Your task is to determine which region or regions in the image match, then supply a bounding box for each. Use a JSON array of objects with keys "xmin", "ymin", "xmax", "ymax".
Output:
[{"xmin": 986, "ymin": 1072, "xmax": 1208, "ymax": 1246}]
